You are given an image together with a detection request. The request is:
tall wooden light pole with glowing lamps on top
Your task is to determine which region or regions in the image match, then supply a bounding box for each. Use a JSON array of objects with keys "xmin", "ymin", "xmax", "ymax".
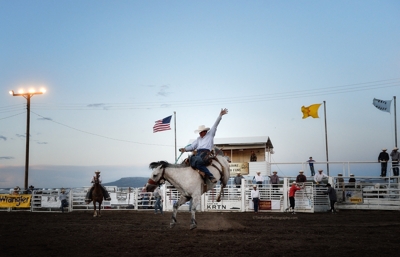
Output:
[{"xmin": 9, "ymin": 89, "xmax": 46, "ymax": 190}]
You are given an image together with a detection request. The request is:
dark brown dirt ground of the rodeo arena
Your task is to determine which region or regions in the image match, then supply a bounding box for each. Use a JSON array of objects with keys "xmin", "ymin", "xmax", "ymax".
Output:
[{"xmin": 0, "ymin": 211, "xmax": 400, "ymax": 257}]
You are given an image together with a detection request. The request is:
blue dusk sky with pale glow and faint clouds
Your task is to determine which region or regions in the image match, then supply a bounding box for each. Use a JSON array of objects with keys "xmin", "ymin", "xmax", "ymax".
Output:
[{"xmin": 0, "ymin": 0, "xmax": 400, "ymax": 188}]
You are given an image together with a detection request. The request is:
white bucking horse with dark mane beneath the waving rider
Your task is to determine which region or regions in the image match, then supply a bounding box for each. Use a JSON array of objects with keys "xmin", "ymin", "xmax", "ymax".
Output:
[{"xmin": 146, "ymin": 150, "xmax": 230, "ymax": 229}]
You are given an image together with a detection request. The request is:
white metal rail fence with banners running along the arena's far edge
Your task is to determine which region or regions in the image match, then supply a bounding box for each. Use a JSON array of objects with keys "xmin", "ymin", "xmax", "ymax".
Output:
[{"xmin": 0, "ymin": 174, "xmax": 400, "ymax": 213}]
